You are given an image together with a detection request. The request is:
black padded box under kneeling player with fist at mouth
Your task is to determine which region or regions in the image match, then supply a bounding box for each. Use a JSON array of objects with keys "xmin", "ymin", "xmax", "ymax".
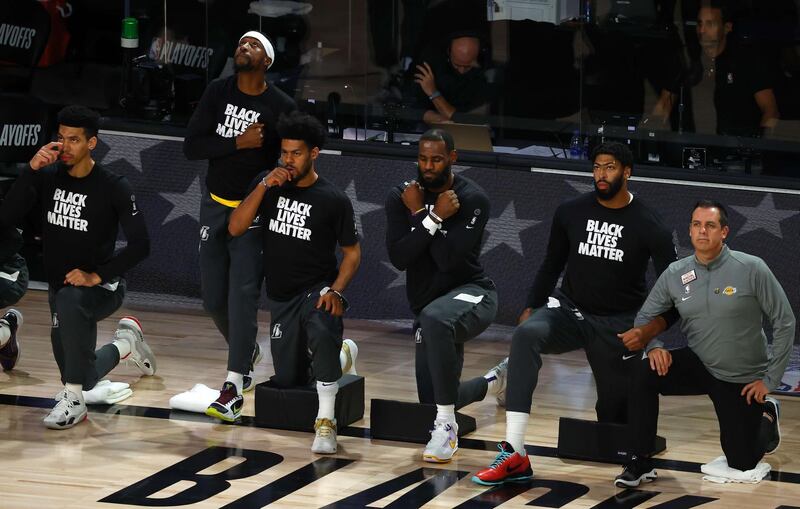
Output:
[{"xmin": 255, "ymin": 375, "xmax": 364, "ymax": 432}]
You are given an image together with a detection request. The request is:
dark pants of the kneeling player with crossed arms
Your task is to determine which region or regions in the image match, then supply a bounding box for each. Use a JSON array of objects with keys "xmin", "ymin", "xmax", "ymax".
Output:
[{"xmin": 414, "ymin": 284, "xmax": 497, "ymax": 409}]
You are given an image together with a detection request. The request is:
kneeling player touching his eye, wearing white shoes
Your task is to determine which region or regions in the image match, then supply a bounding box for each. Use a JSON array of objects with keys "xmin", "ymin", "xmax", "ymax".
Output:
[{"xmin": 0, "ymin": 106, "xmax": 156, "ymax": 429}]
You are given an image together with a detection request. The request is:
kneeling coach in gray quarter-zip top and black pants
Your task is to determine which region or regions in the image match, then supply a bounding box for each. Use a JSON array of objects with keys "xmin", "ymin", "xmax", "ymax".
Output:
[{"xmin": 614, "ymin": 201, "xmax": 795, "ymax": 487}]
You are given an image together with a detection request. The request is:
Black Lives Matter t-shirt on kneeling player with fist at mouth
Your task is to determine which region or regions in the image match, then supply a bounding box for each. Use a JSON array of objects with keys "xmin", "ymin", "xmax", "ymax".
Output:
[{"xmin": 251, "ymin": 176, "xmax": 358, "ymax": 301}]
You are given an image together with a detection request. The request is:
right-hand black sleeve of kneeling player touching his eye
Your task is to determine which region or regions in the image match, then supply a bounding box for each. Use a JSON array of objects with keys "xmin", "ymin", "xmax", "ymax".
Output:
[{"xmin": 96, "ymin": 177, "xmax": 150, "ymax": 282}]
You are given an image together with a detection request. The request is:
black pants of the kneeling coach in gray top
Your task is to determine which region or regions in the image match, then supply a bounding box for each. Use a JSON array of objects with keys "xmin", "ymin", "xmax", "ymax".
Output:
[{"xmin": 628, "ymin": 348, "xmax": 769, "ymax": 470}]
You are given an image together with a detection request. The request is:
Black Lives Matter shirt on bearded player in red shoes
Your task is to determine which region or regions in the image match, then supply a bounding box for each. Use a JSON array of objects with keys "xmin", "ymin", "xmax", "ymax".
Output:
[{"xmin": 527, "ymin": 192, "xmax": 677, "ymax": 315}]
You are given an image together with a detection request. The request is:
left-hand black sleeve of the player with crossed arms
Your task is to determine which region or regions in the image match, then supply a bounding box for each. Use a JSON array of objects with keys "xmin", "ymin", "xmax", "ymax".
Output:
[{"xmin": 385, "ymin": 188, "xmax": 433, "ymax": 270}]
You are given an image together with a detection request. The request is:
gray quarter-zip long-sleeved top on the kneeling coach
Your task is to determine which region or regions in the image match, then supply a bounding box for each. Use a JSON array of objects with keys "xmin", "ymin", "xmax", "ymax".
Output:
[{"xmin": 635, "ymin": 246, "xmax": 795, "ymax": 391}]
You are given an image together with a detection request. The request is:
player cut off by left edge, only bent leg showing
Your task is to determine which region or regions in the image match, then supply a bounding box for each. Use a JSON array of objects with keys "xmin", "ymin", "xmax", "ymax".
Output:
[{"xmin": 0, "ymin": 222, "xmax": 28, "ymax": 371}]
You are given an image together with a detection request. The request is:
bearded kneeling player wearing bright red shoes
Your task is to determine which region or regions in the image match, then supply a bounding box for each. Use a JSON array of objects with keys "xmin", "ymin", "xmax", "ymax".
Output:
[{"xmin": 472, "ymin": 143, "xmax": 676, "ymax": 485}]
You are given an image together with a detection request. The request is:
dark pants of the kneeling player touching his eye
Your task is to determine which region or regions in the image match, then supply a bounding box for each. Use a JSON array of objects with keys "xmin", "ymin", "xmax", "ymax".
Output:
[{"xmin": 48, "ymin": 279, "xmax": 125, "ymax": 391}]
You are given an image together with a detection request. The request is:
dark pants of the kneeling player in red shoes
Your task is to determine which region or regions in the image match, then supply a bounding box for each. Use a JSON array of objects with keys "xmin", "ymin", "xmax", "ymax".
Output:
[{"xmin": 506, "ymin": 295, "xmax": 641, "ymax": 423}]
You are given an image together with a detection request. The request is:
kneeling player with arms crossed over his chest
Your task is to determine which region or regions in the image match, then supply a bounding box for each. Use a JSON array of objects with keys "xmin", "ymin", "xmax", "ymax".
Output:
[{"xmin": 386, "ymin": 129, "xmax": 506, "ymax": 463}]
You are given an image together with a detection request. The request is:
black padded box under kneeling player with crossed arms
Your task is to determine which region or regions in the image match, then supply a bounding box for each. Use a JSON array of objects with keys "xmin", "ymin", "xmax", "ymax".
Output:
[{"xmin": 369, "ymin": 399, "xmax": 477, "ymax": 444}]
